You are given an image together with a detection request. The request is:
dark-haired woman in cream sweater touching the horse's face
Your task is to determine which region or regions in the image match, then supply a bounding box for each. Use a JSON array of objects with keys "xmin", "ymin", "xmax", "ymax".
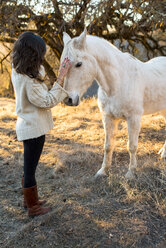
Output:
[{"xmin": 12, "ymin": 32, "xmax": 70, "ymax": 217}]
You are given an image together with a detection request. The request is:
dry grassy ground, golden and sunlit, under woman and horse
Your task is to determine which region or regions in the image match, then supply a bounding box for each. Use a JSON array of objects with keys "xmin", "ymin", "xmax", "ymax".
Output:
[{"xmin": 0, "ymin": 98, "xmax": 166, "ymax": 248}]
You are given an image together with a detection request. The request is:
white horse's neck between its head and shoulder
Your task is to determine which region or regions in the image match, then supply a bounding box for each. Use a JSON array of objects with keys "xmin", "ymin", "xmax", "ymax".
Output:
[{"xmin": 87, "ymin": 37, "xmax": 123, "ymax": 96}]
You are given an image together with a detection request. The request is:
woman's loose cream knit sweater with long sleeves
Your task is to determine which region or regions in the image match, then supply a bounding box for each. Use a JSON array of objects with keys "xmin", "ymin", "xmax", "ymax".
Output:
[{"xmin": 12, "ymin": 67, "xmax": 68, "ymax": 141}]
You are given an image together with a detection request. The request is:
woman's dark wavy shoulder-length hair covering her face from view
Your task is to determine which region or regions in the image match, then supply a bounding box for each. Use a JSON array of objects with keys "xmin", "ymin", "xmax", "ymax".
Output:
[{"xmin": 12, "ymin": 32, "xmax": 46, "ymax": 81}]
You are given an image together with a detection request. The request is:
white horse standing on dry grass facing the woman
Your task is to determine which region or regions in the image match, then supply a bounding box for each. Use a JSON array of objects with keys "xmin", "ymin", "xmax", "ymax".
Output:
[{"xmin": 61, "ymin": 29, "xmax": 166, "ymax": 178}]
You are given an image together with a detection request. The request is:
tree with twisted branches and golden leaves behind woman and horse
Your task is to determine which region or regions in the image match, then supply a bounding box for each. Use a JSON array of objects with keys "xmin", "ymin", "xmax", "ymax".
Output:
[{"xmin": 0, "ymin": 0, "xmax": 166, "ymax": 92}]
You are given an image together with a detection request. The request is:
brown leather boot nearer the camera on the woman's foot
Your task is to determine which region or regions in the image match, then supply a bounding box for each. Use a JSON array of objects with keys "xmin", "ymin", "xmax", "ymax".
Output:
[{"xmin": 23, "ymin": 185, "xmax": 50, "ymax": 217}]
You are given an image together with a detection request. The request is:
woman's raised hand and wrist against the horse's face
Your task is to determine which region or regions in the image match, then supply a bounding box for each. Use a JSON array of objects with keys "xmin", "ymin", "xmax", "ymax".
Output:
[{"xmin": 57, "ymin": 57, "xmax": 71, "ymax": 86}]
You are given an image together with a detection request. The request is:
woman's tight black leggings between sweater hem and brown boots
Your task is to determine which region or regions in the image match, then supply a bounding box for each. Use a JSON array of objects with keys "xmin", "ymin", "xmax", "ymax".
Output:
[{"xmin": 23, "ymin": 135, "xmax": 45, "ymax": 188}]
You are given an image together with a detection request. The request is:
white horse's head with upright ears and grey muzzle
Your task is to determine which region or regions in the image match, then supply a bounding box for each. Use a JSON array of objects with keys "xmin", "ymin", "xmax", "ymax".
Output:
[{"xmin": 61, "ymin": 29, "xmax": 96, "ymax": 106}]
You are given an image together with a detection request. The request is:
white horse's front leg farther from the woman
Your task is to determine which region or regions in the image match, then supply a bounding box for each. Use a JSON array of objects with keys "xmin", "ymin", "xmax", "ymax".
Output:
[{"xmin": 126, "ymin": 115, "xmax": 141, "ymax": 179}]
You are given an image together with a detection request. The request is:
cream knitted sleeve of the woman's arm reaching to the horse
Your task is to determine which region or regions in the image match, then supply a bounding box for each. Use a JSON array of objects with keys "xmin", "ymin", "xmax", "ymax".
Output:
[{"xmin": 26, "ymin": 81, "xmax": 68, "ymax": 109}]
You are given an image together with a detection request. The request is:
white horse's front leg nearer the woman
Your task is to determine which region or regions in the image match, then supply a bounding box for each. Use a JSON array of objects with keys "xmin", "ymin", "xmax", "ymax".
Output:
[{"xmin": 95, "ymin": 115, "xmax": 118, "ymax": 177}]
